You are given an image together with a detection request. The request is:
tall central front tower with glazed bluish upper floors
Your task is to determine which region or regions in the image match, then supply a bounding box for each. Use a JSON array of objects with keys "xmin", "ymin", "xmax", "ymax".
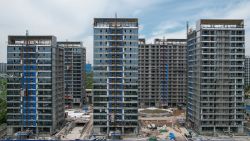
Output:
[{"xmin": 93, "ymin": 18, "xmax": 138, "ymax": 136}]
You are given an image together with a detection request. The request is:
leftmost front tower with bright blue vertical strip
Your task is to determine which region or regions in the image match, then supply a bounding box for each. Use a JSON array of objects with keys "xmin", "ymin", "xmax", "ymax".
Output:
[{"xmin": 7, "ymin": 35, "xmax": 64, "ymax": 136}]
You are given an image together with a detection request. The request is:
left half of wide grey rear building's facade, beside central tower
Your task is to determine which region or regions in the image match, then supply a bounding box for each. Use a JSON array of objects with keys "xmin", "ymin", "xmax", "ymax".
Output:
[{"xmin": 138, "ymin": 43, "xmax": 161, "ymax": 108}]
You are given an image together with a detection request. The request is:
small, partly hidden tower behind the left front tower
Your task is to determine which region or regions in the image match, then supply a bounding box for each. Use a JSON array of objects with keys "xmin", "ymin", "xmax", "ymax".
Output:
[{"xmin": 57, "ymin": 41, "xmax": 86, "ymax": 108}]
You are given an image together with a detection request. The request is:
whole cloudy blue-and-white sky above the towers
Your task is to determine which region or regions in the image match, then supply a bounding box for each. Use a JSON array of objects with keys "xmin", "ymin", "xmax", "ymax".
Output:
[{"xmin": 0, "ymin": 0, "xmax": 250, "ymax": 63}]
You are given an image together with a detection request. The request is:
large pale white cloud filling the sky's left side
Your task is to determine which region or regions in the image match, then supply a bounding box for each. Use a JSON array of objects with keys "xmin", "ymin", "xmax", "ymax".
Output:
[{"xmin": 0, "ymin": 0, "xmax": 160, "ymax": 62}]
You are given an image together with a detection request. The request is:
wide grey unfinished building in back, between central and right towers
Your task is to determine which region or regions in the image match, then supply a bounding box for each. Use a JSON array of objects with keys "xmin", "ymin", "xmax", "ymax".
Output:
[{"xmin": 138, "ymin": 39, "xmax": 187, "ymax": 107}]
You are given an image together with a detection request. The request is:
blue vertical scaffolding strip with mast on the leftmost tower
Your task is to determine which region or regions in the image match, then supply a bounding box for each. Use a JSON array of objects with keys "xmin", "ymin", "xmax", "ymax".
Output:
[{"xmin": 20, "ymin": 31, "xmax": 37, "ymax": 135}]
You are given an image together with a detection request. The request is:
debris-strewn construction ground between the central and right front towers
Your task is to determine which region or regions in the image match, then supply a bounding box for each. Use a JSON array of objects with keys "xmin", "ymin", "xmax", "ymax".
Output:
[{"xmin": 137, "ymin": 109, "xmax": 188, "ymax": 141}]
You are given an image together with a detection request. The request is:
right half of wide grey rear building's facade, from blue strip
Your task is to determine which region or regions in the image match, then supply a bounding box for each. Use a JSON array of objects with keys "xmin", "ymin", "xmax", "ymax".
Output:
[{"xmin": 161, "ymin": 39, "xmax": 187, "ymax": 107}]
